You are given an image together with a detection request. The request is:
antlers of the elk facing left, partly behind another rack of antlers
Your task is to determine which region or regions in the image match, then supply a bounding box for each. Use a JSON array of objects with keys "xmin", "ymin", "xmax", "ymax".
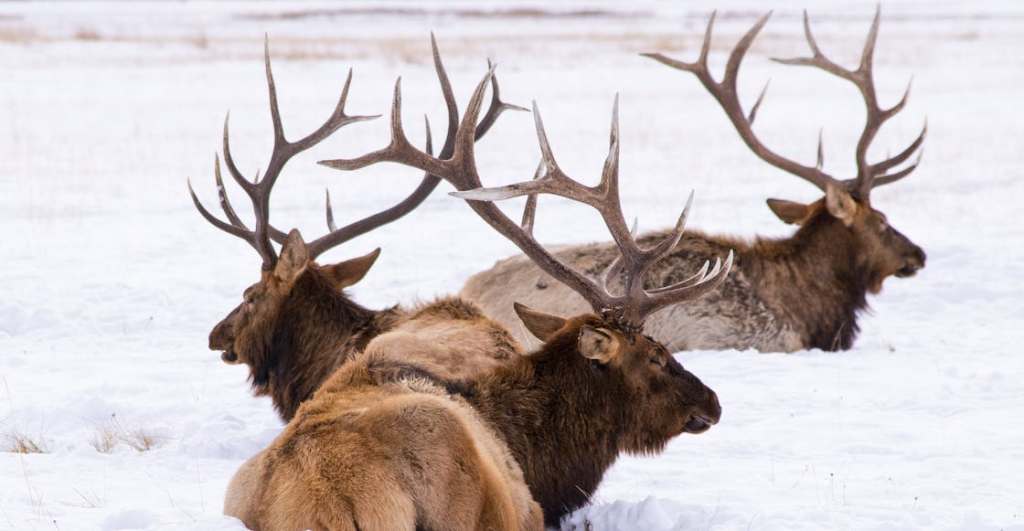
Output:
[{"xmin": 188, "ymin": 36, "xmax": 518, "ymax": 270}]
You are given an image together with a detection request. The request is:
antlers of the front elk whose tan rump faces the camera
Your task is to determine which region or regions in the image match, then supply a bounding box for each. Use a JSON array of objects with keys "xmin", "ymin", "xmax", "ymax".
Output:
[{"xmin": 321, "ymin": 44, "xmax": 732, "ymax": 328}]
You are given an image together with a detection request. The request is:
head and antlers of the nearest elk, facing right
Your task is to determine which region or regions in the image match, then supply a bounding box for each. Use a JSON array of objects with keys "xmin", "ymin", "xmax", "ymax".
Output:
[{"xmin": 322, "ymin": 63, "xmax": 732, "ymax": 452}]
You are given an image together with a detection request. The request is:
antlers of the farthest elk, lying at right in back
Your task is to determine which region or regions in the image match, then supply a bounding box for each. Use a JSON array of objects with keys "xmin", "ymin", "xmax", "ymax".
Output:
[{"xmin": 641, "ymin": 7, "xmax": 928, "ymax": 201}]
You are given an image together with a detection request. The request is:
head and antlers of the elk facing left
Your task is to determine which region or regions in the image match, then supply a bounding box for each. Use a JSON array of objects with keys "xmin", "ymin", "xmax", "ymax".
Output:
[{"xmin": 188, "ymin": 38, "xmax": 515, "ymax": 387}]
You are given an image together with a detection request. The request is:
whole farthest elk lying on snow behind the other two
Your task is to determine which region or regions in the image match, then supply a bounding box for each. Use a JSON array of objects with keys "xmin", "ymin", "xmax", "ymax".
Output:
[{"xmin": 460, "ymin": 8, "xmax": 925, "ymax": 352}]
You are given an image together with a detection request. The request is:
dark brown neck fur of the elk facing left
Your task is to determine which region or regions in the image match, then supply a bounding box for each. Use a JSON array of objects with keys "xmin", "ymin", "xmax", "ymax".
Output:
[{"xmin": 252, "ymin": 271, "xmax": 398, "ymax": 422}]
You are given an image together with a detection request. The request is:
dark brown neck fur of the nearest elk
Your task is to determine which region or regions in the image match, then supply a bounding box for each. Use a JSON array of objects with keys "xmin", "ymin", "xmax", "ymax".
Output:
[{"xmin": 461, "ymin": 318, "xmax": 630, "ymax": 526}]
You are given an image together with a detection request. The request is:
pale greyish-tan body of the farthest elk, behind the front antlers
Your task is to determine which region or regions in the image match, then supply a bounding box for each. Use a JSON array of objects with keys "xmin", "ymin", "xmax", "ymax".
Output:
[{"xmin": 459, "ymin": 231, "xmax": 805, "ymax": 352}]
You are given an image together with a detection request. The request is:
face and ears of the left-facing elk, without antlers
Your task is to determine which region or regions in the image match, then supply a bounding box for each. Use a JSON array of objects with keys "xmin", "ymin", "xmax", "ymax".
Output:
[{"xmin": 210, "ymin": 230, "xmax": 380, "ymax": 367}]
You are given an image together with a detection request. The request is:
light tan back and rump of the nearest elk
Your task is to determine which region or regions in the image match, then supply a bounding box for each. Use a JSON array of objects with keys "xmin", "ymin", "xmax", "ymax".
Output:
[{"xmin": 224, "ymin": 352, "xmax": 543, "ymax": 531}]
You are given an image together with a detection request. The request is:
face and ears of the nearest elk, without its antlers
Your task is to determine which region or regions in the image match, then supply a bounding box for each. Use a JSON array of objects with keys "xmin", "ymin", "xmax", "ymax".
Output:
[{"xmin": 516, "ymin": 305, "xmax": 722, "ymax": 453}]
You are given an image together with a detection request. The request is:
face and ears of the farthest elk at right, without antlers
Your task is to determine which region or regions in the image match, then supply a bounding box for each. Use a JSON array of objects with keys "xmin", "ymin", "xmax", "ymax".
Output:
[{"xmin": 768, "ymin": 185, "xmax": 927, "ymax": 294}]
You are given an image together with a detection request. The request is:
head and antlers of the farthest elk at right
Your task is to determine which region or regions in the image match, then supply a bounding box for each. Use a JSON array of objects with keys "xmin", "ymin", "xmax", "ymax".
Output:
[{"xmin": 642, "ymin": 8, "xmax": 928, "ymax": 293}]
